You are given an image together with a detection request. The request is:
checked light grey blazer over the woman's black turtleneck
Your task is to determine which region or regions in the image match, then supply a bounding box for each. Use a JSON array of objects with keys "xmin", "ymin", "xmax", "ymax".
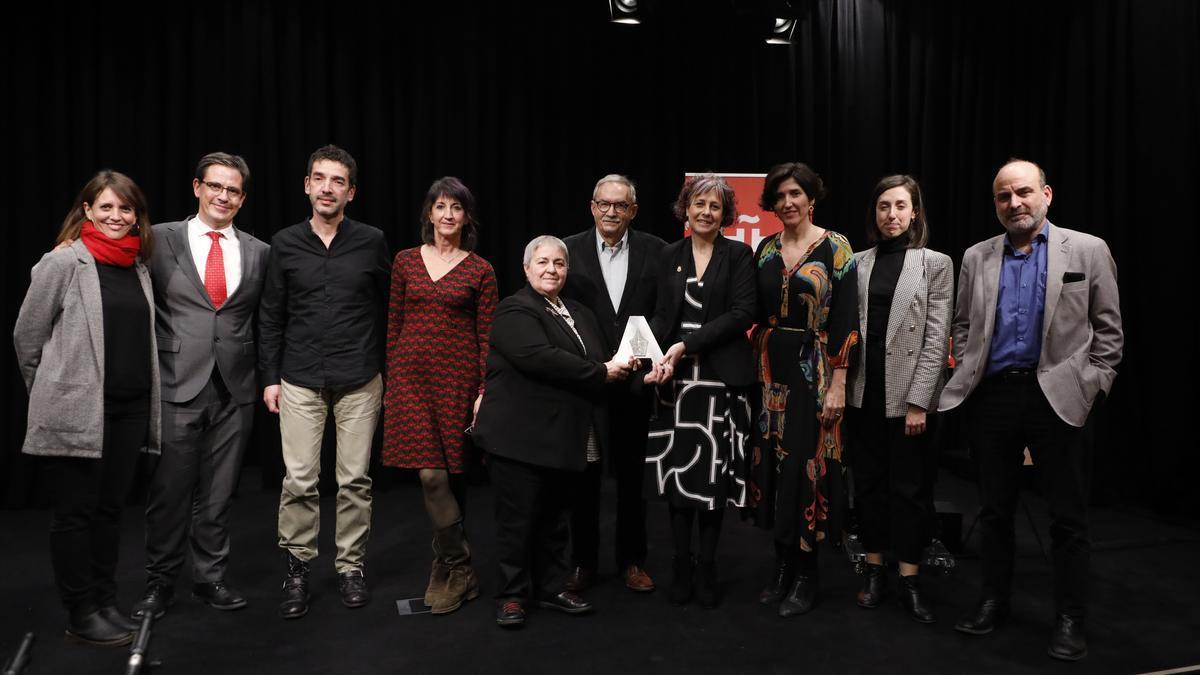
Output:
[{"xmin": 848, "ymin": 247, "xmax": 954, "ymax": 417}]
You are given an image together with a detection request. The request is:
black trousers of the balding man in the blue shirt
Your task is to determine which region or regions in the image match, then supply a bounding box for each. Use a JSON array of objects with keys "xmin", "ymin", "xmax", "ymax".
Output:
[{"xmin": 968, "ymin": 375, "xmax": 1091, "ymax": 616}]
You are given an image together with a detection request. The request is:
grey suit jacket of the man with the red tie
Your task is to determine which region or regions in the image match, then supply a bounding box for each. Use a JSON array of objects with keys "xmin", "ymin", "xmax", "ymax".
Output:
[{"xmin": 150, "ymin": 220, "xmax": 270, "ymax": 404}]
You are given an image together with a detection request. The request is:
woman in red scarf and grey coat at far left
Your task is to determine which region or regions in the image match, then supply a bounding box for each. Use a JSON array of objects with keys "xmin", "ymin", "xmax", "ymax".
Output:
[{"xmin": 13, "ymin": 171, "xmax": 160, "ymax": 645}]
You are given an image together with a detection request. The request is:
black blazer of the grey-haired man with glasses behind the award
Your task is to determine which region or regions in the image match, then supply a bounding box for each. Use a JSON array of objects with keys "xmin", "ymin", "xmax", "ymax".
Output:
[{"xmin": 563, "ymin": 227, "xmax": 666, "ymax": 356}]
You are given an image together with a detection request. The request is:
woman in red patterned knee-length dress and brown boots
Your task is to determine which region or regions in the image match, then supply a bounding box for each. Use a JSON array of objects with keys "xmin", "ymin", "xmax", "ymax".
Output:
[{"xmin": 383, "ymin": 177, "xmax": 497, "ymax": 614}]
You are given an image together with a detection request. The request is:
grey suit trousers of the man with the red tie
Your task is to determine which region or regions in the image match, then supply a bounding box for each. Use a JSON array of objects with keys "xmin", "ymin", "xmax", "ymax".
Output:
[{"xmin": 146, "ymin": 368, "xmax": 254, "ymax": 586}]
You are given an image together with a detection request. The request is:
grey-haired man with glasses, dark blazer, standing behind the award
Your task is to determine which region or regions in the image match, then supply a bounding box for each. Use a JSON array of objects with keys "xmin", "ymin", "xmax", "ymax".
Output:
[{"xmin": 563, "ymin": 174, "xmax": 666, "ymax": 592}]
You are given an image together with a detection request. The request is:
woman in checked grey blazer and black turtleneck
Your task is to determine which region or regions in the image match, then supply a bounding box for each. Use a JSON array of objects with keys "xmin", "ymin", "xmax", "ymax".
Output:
[{"xmin": 847, "ymin": 175, "xmax": 954, "ymax": 623}]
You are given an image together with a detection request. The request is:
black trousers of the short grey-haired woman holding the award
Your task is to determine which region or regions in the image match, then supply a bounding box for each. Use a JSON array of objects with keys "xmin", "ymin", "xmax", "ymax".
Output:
[{"xmin": 487, "ymin": 455, "xmax": 578, "ymax": 601}]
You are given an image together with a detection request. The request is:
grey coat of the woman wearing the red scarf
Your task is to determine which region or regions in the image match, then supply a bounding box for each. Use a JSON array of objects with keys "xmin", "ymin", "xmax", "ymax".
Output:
[{"xmin": 12, "ymin": 240, "xmax": 161, "ymax": 459}]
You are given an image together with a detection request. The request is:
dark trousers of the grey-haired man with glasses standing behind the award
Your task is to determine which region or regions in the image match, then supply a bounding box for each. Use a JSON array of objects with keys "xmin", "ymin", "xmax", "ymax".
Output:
[{"xmin": 571, "ymin": 394, "xmax": 649, "ymax": 573}]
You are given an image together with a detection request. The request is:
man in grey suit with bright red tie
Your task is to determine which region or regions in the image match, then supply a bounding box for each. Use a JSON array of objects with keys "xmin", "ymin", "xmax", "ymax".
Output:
[{"xmin": 133, "ymin": 153, "xmax": 268, "ymax": 619}]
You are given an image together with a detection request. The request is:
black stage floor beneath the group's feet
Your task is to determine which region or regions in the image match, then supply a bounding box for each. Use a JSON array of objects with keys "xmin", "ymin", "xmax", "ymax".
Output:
[{"xmin": 0, "ymin": 471, "xmax": 1200, "ymax": 675}]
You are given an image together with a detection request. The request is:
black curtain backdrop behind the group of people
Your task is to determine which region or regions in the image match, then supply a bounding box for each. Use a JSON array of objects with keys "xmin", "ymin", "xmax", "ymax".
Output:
[{"xmin": 0, "ymin": 0, "xmax": 1200, "ymax": 513}]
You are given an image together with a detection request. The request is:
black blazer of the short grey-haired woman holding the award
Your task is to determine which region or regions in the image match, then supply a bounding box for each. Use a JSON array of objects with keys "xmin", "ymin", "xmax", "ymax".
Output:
[{"xmin": 474, "ymin": 285, "xmax": 607, "ymax": 471}]
